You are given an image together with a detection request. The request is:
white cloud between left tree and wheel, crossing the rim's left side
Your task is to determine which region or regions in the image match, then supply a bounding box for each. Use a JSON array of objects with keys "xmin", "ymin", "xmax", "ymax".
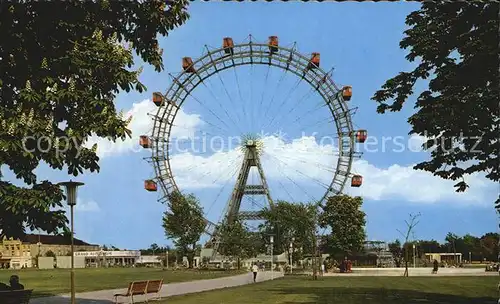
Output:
[{"xmin": 85, "ymin": 99, "xmax": 203, "ymax": 158}]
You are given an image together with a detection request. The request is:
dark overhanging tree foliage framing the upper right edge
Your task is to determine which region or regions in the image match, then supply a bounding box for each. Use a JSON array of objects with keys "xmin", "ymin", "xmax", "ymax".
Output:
[{"xmin": 372, "ymin": 1, "xmax": 500, "ymax": 208}]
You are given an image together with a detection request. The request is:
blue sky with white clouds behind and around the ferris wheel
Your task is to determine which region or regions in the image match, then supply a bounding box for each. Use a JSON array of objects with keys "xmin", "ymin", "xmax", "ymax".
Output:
[{"xmin": 3, "ymin": 2, "xmax": 499, "ymax": 249}]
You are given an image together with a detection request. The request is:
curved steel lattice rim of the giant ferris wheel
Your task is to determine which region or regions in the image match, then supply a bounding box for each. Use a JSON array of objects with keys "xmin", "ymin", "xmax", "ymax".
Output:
[{"xmin": 151, "ymin": 37, "xmax": 356, "ymax": 209}]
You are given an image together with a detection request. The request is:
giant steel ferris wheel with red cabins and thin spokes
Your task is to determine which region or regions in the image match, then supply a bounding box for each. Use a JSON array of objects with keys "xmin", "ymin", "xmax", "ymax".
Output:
[{"xmin": 140, "ymin": 36, "xmax": 367, "ymax": 254}]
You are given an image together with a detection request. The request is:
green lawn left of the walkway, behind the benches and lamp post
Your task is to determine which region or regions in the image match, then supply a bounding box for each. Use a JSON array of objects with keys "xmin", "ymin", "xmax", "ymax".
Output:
[{"xmin": 0, "ymin": 268, "xmax": 241, "ymax": 297}]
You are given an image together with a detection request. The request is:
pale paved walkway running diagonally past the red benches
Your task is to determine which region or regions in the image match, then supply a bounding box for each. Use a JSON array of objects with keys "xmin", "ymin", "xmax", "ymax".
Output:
[{"xmin": 30, "ymin": 271, "xmax": 283, "ymax": 304}]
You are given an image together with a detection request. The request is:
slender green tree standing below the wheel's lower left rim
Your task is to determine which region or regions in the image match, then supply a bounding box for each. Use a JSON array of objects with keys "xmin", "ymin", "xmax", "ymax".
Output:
[{"xmin": 162, "ymin": 192, "xmax": 205, "ymax": 268}]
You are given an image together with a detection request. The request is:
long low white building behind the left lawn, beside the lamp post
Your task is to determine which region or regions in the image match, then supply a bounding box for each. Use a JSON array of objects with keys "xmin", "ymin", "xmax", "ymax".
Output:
[{"xmin": 74, "ymin": 250, "xmax": 141, "ymax": 267}]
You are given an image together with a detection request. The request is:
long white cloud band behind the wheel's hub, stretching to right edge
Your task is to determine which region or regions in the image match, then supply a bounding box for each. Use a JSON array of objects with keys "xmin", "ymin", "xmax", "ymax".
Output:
[{"xmin": 165, "ymin": 136, "xmax": 495, "ymax": 205}]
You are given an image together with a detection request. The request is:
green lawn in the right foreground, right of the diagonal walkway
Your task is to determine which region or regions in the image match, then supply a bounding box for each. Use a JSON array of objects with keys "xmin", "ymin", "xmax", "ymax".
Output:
[{"xmin": 162, "ymin": 276, "xmax": 498, "ymax": 304}]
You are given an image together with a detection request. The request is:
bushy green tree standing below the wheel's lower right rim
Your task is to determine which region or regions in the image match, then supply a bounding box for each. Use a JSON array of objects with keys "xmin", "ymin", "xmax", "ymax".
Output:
[{"xmin": 319, "ymin": 195, "xmax": 366, "ymax": 256}]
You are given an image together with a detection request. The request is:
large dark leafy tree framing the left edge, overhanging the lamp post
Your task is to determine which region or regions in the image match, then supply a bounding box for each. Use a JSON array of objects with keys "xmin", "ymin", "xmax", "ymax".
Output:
[{"xmin": 0, "ymin": 0, "xmax": 188, "ymax": 238}]
